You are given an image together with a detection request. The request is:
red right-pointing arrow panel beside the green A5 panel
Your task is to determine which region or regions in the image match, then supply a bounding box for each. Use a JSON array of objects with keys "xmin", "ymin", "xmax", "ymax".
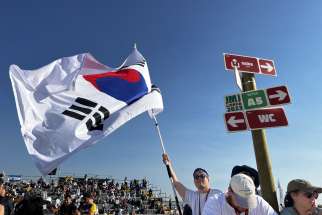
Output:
[{"xmin": 266, "ymin": 86, "xmax": 291, "ymax": 105}]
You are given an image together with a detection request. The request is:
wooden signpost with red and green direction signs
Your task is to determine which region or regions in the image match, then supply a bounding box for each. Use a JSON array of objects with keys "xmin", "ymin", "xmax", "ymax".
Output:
[{"xmin": 224, "ymin": 54, "xmax": 291, "ymax": 211}]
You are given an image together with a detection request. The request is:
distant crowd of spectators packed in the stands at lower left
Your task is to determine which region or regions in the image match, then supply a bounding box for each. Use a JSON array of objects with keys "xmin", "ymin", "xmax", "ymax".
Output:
[{"xmin": 0, "ymin": 175, "xmax": 176, "ymax": 215}]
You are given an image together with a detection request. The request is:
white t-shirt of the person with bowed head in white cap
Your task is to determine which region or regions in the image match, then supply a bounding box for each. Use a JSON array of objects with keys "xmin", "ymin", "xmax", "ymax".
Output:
[{"xmin": 202, "ymin": 193, "xmax": 277, "ymax": 215}]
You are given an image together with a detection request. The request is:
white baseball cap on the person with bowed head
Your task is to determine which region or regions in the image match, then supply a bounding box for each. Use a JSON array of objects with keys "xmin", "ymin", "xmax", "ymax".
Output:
[{"xmin": 230, "ymin": 173, "xmax": 257, "ymax": 208}]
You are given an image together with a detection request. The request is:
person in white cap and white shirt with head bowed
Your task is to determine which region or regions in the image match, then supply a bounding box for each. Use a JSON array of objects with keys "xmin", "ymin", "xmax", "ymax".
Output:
[{"xmin": 202, "ymin": 173, "xmax": 277, "ymax": 215}]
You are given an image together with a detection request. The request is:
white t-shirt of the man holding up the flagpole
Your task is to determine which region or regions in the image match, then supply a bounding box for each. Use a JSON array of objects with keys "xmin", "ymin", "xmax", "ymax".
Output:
[{"xmin": 184, "ymin": 189, "xmax": 222, "ymax": 215}]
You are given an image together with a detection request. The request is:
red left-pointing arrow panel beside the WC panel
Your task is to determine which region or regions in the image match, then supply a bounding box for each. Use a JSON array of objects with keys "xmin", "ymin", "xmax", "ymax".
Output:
[{"xmin": 225, "ymin": 112, "xmax": 247, "ymax": 131}]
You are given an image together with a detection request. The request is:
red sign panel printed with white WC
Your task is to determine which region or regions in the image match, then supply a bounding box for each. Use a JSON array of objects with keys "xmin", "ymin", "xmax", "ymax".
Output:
[{"xmin": 246, "ymin": 108, "xmax": 288, "ymax": 130}]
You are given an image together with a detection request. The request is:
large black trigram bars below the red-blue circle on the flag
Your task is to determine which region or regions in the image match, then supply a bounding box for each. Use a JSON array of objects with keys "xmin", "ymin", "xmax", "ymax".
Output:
[{"xmin": 63, "ymin": 97, "xmax": 110, "ymax": 131}]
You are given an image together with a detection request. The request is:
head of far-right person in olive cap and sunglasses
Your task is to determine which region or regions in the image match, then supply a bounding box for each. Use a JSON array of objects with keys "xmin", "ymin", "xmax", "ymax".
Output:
[{"xmin": 284, "ymin": 179, "xmax": 322, "ymax": 211}]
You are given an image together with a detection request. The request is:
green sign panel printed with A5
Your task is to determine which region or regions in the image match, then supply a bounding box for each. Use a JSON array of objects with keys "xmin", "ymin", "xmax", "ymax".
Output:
[{"xmin": 242, "ymin": 90, "xmax": 268, "ymax": 110}]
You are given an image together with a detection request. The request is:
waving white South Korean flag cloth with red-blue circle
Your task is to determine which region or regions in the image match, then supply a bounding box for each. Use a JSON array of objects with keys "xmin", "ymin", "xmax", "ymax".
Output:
[{"xmin": 9, "ymin": 48, "xmax": 163, "ymax": 175}]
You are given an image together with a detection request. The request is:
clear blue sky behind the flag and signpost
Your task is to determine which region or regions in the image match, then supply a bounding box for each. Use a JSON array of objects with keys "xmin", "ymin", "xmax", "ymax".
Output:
[{"xmin": 0, "ymin": 0, "xmax": 322, "ymax": 203}]
